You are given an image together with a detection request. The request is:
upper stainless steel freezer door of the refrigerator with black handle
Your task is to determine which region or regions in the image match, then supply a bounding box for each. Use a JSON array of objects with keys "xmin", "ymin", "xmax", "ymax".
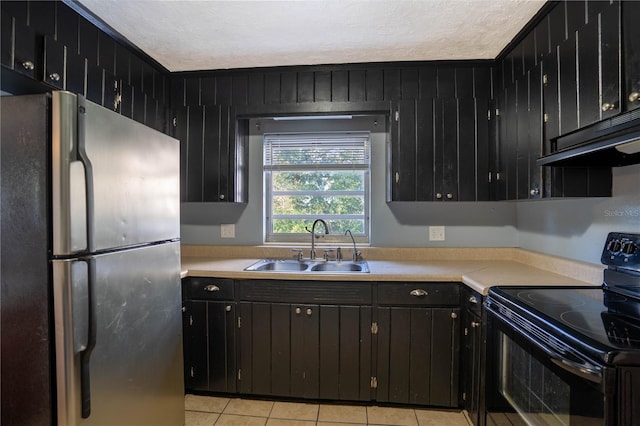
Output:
[{"xmin": 52, "ymin": 92, "xmax": 180, "ymax": 256}]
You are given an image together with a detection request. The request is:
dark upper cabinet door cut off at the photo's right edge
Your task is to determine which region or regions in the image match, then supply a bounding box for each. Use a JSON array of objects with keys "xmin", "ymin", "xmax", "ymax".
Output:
[{"xmin": 621, "ymin": 1, "xmax": 640, "ymax": 109}]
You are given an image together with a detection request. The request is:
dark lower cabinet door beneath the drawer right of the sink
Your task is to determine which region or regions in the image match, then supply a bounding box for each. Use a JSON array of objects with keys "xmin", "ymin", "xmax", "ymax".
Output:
[{"xmin": 376, "ymin": 307, "xmax": 460, "ymax": 407}]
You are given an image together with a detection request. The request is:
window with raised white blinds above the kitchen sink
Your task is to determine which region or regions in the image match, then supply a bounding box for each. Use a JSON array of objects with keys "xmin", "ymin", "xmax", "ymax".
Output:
[{"xmin": 263, "ymin": 132, "xmax": 371, "ymax": 243}]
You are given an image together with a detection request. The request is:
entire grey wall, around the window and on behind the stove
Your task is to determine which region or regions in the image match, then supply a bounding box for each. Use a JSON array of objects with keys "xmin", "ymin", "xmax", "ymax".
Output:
[{"xmin": 181, "ymin": 120, "xmax": 640, "ymax": 264}]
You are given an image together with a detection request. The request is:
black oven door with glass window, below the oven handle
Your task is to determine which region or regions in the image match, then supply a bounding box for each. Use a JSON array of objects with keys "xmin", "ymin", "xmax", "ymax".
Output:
[{"xmin": 486, "ymin": 309, "xmax": 615, "ymax": 426}]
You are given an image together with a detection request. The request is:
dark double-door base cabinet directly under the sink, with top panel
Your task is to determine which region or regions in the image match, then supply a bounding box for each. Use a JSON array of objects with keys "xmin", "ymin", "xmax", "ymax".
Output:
[{"xmin": 238, "ymin": 280, "xmax": 372, "ymax": 401}]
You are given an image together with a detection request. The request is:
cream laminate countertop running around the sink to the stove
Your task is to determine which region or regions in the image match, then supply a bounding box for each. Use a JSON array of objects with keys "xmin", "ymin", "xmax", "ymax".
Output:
[{"xmin": 182, "ymin": 247, "xmax": 602, "ymax": 295}]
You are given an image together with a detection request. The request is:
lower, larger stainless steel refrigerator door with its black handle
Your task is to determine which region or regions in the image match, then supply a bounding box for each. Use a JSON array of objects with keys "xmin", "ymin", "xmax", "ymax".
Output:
[{"xmin": 53, "ymin": 242, "xmax": 184, "ymax": 426}]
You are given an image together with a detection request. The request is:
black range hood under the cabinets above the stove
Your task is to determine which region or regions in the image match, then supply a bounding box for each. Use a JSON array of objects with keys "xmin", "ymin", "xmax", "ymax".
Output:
[{"xmin": 536, "ymin": 109, "xmax": 640, "ymax": 167}]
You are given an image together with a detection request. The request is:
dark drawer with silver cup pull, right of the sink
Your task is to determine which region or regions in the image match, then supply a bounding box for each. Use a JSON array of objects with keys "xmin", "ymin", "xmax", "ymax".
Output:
[{"xmin": 378, "ymin": 283, "xmax": 460, "ymax": 306}]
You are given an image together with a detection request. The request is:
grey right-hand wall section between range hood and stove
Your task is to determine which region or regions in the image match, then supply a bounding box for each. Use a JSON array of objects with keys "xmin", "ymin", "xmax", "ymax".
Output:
[{"xmin": 517, "ymin": 165, "xmax": 640, "ymax": 263}]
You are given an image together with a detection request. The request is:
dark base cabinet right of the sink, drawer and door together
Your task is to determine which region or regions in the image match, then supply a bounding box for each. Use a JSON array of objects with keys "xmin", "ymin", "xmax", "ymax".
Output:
[{"xmin": 375, "ymin": 283, "xmax": 460, "ymax": 407}]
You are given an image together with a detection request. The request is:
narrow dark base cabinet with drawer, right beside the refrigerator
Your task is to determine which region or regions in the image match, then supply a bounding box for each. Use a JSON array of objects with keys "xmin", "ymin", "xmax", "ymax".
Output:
[{"xmin": 182, "ymin": 277, "xmax": 237, "ymax": 392}]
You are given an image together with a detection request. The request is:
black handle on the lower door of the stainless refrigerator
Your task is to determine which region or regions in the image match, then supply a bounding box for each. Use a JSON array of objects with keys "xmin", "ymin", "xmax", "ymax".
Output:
[{"xmin": 80, "ymin": 258, "xmax": 97, "ymax": 419}]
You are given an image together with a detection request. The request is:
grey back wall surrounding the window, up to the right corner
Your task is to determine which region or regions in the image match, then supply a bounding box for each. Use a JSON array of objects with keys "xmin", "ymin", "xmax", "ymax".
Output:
[{"xmin": 181, "ymin": 118, "xmax": 517, "ymax": 247}]
